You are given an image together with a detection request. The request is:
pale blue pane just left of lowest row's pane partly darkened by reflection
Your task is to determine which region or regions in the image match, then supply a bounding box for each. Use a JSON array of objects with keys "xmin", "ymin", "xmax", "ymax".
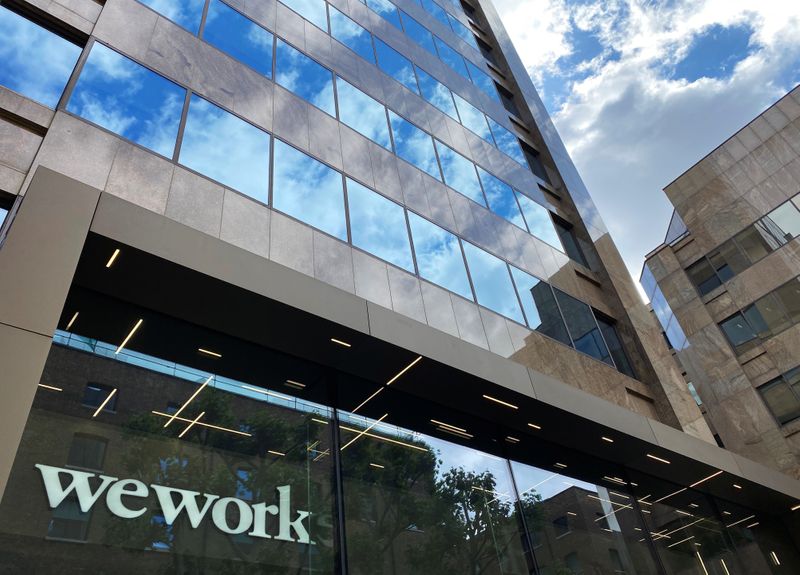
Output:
[{"xmin": 464, "ymin": 242, "xmax": 525, "ymax": 323}]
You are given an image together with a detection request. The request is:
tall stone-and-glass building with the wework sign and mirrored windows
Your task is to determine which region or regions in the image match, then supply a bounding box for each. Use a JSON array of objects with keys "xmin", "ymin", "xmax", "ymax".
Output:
[{"xmin": 0, "ymin": 0, "xmax": 800, "ymax": 575}]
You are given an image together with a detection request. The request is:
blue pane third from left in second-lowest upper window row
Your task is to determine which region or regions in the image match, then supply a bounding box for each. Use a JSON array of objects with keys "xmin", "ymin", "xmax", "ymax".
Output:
[{"xmin": 275, "ymin": 39, "xmax": 336, "ymax": 116}]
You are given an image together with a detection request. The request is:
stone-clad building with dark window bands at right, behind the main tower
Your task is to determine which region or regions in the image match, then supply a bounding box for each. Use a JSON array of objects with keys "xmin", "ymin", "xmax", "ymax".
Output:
[{"xmin": 642, "ymin": 89, "xmax": 800, "ymax": 477}]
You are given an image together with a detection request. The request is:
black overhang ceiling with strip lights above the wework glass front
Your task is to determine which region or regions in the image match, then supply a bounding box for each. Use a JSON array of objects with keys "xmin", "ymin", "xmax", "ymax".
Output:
[{"xmin": 59, "ymin": 234, "xmax": 794, "ymax": 512}]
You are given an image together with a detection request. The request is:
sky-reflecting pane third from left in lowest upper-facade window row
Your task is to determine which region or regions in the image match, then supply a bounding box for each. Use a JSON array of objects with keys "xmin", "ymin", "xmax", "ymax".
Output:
[{"xmin": 179, "ymin": 95, "xmax": 269, "ymax": 203}]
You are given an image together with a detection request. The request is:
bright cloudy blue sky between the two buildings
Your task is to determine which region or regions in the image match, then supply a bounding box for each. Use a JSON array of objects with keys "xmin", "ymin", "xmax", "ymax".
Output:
[{"xmin": 495, "ymin": 0, "xmax": 800, "ymax": 294}]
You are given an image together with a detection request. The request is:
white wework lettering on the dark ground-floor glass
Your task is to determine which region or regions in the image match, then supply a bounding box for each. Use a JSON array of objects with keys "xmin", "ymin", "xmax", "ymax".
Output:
[{"xmin": 36, "ymin": 463, "xmax": 315, "ymax": 545}]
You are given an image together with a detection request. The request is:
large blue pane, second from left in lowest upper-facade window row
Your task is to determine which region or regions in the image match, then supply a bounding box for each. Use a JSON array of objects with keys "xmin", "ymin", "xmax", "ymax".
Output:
[{"xmin": 67, "ymin": 43, "xmax": 186, "ymax": 158}]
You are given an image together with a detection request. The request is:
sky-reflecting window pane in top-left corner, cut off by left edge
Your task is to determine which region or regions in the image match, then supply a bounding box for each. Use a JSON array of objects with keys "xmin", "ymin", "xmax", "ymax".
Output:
[{"xmin": 0, "ymin": 6, "xmax": 81, "ymax": 108}]
